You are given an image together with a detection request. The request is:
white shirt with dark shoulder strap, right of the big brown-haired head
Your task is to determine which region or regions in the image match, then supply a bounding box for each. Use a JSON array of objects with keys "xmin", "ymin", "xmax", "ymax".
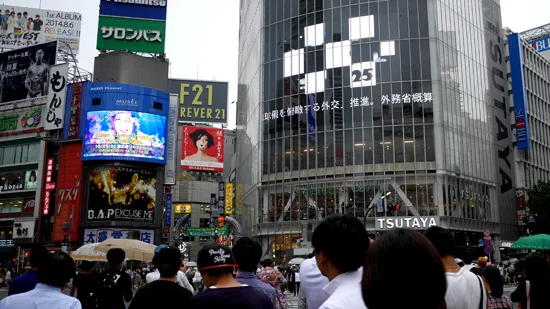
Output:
[{"xmin": 445, "ymin": 267, "xmax": 487, "ymax": 309}]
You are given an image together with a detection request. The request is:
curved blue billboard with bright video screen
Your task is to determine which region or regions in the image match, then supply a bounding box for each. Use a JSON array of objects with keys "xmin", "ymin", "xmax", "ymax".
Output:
[{"xmin": 76, "ymin": 83, "xmax": 169, "ymax": 164}]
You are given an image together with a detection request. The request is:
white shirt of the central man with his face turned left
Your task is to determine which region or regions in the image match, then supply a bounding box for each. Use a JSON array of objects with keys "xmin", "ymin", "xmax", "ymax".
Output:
[{"xmin": 320, "ymin": 267, "xmax": 367, "ymax": 309}]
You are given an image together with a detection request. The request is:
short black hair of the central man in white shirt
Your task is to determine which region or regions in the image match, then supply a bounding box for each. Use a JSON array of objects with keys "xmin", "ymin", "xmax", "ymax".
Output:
[{"xmin": 311, "ymin": 214, "xmax": 370, "ymax": 273}]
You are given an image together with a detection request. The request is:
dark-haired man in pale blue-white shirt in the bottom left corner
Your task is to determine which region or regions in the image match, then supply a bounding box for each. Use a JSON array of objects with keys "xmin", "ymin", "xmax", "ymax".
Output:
[{"xmin": 0, "ymin": 252, "xmax": 82, "ymax": 309}]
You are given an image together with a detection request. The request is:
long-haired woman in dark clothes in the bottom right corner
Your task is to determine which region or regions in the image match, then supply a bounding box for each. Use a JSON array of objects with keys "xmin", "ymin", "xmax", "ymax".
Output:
[{"xmin": 512, "ymin": 255, "xmax": 550, "ymax": 309}]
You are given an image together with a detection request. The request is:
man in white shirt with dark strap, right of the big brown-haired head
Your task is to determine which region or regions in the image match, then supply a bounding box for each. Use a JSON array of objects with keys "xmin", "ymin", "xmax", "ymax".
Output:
[{"xmin": 426, "ymin": 226, "xmax": 487, "ymax": 309}]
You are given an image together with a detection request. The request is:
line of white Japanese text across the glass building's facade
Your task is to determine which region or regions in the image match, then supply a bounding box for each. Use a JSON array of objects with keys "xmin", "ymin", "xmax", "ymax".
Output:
[{"xmin": 264, "ymin": 92, "xmax": 433, "ymax": 121}]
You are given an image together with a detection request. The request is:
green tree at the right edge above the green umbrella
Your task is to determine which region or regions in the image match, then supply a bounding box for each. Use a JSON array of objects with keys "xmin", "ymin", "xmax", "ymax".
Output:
[{"xmin": 526, "ymin": 181, "xmax": 550, "ymax": 233}]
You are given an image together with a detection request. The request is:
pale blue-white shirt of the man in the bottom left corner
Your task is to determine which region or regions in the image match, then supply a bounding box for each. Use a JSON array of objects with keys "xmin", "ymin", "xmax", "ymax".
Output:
[{"xmin": 0, "ymin": 283, "xmax": 82, "ymax": 309}]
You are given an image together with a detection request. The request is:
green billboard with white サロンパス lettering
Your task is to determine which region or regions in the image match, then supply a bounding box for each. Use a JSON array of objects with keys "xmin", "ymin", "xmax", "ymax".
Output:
[{"xmin": 97, "ymin": 16, "xmax": 166, "ymax": 54}]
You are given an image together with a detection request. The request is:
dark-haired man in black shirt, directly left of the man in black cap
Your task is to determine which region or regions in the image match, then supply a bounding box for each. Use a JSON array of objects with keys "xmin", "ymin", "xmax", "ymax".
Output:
[{"xmin": 129, "ymin": 247, "xmax": 193, "ymax": 309}]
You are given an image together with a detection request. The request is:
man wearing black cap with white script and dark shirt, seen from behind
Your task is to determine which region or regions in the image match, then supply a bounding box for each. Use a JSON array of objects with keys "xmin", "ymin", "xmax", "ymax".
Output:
[{"xmin": 191, "ymin": 244, "xmax": 273, "ymax": 309}]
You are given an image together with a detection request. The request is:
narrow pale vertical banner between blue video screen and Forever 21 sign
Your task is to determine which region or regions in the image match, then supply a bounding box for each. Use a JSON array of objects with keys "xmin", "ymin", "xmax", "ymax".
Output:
[{"xmin": 164, "ymin": 95, "xmax": 178, "ymax": 185}]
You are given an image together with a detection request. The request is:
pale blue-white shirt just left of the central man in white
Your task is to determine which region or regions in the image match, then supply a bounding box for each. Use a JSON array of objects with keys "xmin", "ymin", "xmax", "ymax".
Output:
[{"xmin": 298, "ymin": 257, "xmax": 328, "ymax": 309}]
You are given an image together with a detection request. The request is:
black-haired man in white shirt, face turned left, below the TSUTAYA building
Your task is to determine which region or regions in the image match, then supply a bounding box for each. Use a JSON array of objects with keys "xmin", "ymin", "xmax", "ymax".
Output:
[{"xmin": 311, "ymin": 215, "xmax": 370, "ymax": 309}]
